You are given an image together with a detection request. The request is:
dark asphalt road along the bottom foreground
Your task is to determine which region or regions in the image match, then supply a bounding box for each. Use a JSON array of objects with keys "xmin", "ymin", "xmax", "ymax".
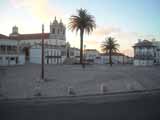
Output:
[{"xmin": 0, "ymin": 91, "xmax": 160, "ymax": 120}]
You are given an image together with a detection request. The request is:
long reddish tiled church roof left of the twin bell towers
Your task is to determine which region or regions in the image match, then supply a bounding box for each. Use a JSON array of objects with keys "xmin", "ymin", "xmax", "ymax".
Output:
[{"xmin": 9, "ymin": 33, "xmax": 49, "ymax": 40}]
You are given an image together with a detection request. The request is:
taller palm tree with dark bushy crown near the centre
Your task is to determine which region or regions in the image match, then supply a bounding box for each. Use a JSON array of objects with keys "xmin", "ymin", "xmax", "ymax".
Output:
[{"xmin": 69, "ymin": 8, "xmax": 96, "ymax": 64}]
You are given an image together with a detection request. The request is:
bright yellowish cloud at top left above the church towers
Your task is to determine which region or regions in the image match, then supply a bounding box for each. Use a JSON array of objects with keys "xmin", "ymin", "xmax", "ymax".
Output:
[{"xmin": 10, "ymin": 0, "xmax": 63, "ymax": 21}]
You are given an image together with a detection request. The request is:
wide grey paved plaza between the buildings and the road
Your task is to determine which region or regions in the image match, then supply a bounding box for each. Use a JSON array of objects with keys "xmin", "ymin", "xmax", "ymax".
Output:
[{"xmin": 0, "ymin": 64, "xmax": 160, "ymax": 98}]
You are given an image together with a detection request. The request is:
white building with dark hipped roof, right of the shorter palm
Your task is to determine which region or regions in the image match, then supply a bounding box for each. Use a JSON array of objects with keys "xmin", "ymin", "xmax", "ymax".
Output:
[{"xmin": 133, "ymin": 40, "xmax": 156, "ymax": 66}]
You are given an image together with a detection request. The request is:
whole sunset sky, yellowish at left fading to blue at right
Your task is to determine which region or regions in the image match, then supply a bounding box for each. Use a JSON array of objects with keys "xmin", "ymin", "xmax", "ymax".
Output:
[{"xmin": 0, "ymin": 0, "xmax": 160, "ymax": 56}]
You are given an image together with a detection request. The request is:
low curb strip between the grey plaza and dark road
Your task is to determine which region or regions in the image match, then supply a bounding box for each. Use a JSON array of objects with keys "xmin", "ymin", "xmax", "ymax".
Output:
[{"xmin": 0, "ymin": 89, "xmax": 160, "ymax": 103}]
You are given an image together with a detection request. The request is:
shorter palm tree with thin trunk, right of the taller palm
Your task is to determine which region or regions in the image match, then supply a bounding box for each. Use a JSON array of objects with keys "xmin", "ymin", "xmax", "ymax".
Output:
[{"xmin": 101, "ymin": 37, "xmax": 119, "ymax": 66}]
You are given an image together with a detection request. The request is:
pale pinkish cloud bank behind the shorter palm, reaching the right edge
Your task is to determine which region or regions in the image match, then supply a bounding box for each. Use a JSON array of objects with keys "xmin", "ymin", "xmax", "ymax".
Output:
[{"xmin": 84, "ymin": 27, "xmax": 160, "ymax": 56}]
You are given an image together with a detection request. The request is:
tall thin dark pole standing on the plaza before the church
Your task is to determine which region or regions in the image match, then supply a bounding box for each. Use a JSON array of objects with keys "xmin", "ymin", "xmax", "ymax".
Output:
[{"xmin": 41, "ymin": 24, "xmax": 44, "ymax": 80}]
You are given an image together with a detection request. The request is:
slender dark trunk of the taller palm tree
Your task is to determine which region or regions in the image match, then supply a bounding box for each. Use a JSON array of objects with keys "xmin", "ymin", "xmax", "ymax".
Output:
[{"xmin": 80, "ymin": 29, "xmax": 84, "ymax": 64}]
